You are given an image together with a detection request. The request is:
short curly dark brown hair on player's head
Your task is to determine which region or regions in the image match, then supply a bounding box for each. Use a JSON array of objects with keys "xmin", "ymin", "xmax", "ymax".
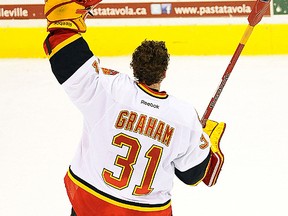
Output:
[{"xmin": 130, "ymin": 40, "xmax": 170, "ymax": 85}]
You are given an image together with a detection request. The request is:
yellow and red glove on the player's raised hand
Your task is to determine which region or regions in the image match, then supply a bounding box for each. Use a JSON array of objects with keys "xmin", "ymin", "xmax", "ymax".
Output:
[{"xmin": 44, "ymin": 0, "xmax": 102, "ymax": 33}]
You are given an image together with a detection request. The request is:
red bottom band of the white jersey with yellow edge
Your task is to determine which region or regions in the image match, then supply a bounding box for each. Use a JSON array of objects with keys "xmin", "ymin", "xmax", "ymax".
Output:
[{"xmin": 64, "ymin": 171, "xmax": 172, "ymax": 216}]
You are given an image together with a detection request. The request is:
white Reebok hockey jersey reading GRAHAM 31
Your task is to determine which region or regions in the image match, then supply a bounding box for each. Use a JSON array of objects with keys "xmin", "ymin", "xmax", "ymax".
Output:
[{"xmin": 44, "ymin": 33, "xmax": 210, "ymax": 216}]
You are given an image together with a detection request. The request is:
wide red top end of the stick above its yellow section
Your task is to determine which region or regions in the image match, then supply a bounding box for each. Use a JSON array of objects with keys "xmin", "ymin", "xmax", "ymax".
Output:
[{"xmin": 248, "ymin": 0, "xmax": 271, "ymax": 26}]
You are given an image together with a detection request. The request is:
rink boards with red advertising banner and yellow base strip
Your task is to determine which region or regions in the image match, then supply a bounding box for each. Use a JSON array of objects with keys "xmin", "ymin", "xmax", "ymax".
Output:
[{"xmin": 0, "ymin": 0, "xmax": 288, "ymax": 58}]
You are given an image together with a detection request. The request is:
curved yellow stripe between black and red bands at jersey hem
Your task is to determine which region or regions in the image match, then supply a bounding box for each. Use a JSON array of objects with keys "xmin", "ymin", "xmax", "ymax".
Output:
[{"xmin": 67, "ymin": 169, "xmax": 171, "ymax": 212}]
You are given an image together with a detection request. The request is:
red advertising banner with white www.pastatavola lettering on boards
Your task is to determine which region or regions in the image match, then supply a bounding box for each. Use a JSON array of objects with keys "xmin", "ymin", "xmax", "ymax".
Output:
[{"xmin": 0, "ymin": 0, "xmax": 272, "ymax": 20}]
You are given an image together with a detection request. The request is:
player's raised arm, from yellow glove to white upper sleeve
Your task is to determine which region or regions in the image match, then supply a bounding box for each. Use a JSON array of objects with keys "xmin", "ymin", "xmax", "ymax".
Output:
[{"xmin": 43, "ymin": 0, "xmax": 101, "ymax": 125}]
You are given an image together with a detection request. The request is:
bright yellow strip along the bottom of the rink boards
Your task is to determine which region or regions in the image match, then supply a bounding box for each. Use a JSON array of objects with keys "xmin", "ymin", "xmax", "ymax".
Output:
[{"xmin": 0, "ymin": 24, "xmax": 288, "ymax": 58}]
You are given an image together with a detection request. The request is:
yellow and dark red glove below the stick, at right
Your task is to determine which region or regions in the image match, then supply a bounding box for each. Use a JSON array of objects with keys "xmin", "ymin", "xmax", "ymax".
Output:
[{"xmin": 203, "ymin": 120, "xmax": 226, "ymax": 187}]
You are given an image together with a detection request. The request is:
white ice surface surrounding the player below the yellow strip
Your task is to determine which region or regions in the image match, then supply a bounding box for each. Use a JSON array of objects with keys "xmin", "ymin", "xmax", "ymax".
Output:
[{"xmin": 0, "ymin": 56, "xmax": 288, "ymax": 216}]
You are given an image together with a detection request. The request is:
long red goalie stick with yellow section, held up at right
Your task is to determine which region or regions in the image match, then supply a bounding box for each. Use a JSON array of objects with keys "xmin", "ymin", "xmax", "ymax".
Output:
[{"xmin": 201, "ymin": 0, "xmax": 271, "ymax": 127}]
